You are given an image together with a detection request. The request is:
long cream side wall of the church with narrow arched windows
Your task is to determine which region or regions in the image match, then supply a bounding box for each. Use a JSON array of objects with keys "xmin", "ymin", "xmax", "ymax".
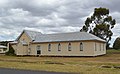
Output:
[{"xmin": 30, "ymin": 41, "xmax": 106, "ymax": 56}]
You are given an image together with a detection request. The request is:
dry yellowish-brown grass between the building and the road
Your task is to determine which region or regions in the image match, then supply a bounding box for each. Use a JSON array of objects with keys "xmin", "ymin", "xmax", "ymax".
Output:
[{"xmin": 0, "ymin": 50, "xmax": 120, "ymax": 74}]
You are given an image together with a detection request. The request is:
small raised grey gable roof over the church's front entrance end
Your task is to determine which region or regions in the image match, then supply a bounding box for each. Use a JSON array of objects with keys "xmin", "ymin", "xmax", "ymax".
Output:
[{"xmin": 16, "ymin": 30, "xmax": 42, "ymax": 41}]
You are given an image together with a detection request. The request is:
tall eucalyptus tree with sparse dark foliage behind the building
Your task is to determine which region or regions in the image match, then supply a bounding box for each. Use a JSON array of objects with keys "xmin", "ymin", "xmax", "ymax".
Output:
[{"xmin": 80, "ymin": 7, "xmax": 116, "ymax": 47}]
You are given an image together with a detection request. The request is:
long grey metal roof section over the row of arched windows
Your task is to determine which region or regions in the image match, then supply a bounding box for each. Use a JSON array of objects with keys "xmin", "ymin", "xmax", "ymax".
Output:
[{"xmin": 33, "ymin": 32, "xmax": 106, "ymax": 43}]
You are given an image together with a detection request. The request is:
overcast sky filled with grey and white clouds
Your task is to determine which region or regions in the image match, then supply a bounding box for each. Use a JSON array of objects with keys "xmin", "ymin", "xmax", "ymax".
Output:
[{"xmin": 0, "ymin": 0, "xmax": 120, "ymax": 44}]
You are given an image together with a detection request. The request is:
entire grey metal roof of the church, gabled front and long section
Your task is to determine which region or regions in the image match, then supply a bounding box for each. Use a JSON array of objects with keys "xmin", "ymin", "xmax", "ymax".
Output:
[{"xmin": 16, "ymin": 30, "xmax": 106, "ymax": 43}]
